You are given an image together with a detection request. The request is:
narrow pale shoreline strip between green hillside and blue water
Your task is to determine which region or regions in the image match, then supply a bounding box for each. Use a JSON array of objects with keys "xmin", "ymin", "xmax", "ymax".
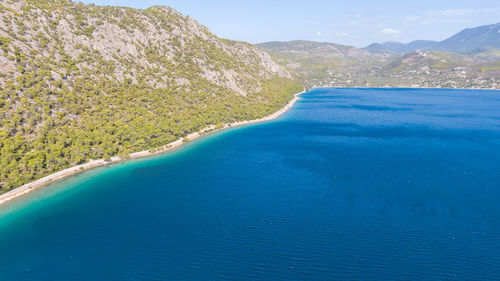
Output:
[{"xmin": 0, "ymin": 90, "xmax": 306, "ymax": 206}]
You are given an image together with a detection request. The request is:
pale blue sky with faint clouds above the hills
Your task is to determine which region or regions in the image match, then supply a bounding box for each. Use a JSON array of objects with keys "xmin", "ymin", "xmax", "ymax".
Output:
[{"xmin": 83, "ymin": 0, "xmax": 500, "ymax": 47}]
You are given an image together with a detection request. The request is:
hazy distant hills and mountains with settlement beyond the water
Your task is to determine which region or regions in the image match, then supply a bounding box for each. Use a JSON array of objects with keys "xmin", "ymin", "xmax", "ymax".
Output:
[{"xmin": 257, "ymin": 24, "xmax": 500, "ymax": 88}]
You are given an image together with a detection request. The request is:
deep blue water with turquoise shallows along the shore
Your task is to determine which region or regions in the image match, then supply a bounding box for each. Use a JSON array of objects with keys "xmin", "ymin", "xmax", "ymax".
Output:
[{"xmin": 0, "ymin": 89, "xmax": 500, "ymax": 281}]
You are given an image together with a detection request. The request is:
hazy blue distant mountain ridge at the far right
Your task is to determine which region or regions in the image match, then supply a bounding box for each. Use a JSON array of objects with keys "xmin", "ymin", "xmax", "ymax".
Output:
[{"xmin": 382, "ymin": 23, "xmax": 500, "ymax": 54}]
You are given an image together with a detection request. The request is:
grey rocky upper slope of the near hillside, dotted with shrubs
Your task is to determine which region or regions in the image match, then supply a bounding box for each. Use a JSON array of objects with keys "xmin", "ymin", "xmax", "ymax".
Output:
[{"xmin": 0, "ymin": 0, "xmax": 291, "ymax": 95}]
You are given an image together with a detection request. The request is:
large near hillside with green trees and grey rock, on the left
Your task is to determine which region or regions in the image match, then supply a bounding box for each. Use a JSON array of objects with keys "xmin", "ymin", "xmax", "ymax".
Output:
[{"xmin": 0, "ymin": 0, "xmax": 301, "ymax": 193}]
